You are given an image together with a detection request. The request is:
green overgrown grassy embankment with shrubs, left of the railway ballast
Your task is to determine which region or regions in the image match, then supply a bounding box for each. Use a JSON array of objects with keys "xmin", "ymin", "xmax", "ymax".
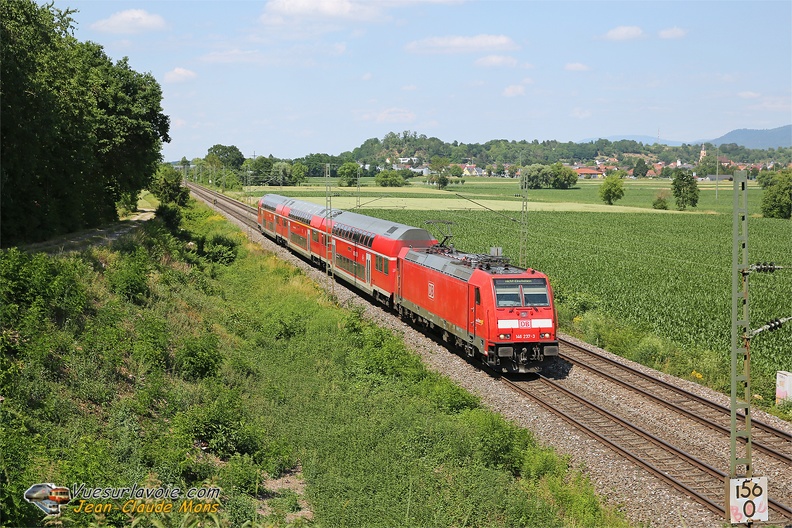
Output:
[{"xmin": 0, "ymin": 199, "xmax": 626, "ymax": 527}]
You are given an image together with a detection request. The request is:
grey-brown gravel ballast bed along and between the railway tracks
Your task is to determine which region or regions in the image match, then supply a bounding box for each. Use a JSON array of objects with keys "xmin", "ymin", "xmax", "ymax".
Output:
[{"xmin": 191, "ymin": 186, "xmax": 792, "ymax": 526}]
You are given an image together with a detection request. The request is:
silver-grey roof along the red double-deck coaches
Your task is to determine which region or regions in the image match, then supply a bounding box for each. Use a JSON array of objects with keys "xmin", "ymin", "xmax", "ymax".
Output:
[{"xmin": 261, "ymin": 194, "xmax": 434, "ymax": 240}]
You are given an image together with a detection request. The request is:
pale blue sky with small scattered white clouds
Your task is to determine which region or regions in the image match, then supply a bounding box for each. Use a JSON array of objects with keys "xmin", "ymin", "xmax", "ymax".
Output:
[{"xmin": 49, "ymin": 0, "xmax": 792, "ymax": 161}]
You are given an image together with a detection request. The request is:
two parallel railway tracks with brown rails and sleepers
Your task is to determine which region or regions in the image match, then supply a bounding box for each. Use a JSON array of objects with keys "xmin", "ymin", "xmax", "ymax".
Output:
[{"xmin": 188, "ymin": 184, "xmax": 792, "ymax": 525}]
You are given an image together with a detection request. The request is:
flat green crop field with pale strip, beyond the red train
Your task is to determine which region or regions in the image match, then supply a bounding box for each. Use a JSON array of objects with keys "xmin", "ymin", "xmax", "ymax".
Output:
[{"xmin": 262, "ymin": 178, "xmax": 792, "ymax": 410}]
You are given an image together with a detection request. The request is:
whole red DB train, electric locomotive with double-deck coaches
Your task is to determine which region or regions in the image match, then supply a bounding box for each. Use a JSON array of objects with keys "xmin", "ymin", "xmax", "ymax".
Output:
[{"xmin": 258, "ymin": 194, "xmax": 558, "ymax": 372}]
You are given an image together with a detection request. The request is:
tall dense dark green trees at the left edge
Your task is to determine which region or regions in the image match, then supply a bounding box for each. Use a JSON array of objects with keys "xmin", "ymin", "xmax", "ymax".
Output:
[{"xmin": 0, "ymin": 0, "xmax": 170, "ymax": 246}]
